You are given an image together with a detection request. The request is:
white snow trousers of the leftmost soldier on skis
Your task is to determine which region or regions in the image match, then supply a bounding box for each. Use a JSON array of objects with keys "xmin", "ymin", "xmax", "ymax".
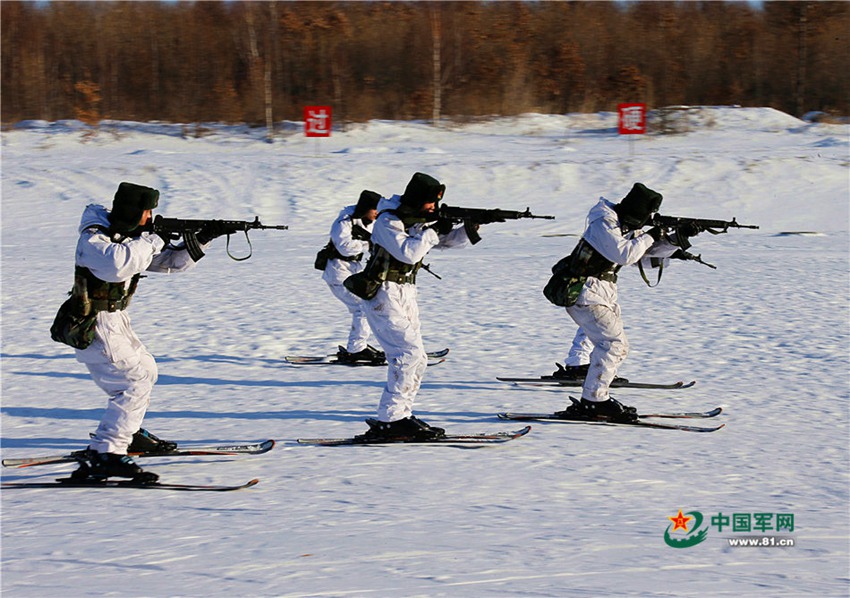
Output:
[{"xmin": 77, "ymin": 311, "xmax": 158, "ymax": 455}]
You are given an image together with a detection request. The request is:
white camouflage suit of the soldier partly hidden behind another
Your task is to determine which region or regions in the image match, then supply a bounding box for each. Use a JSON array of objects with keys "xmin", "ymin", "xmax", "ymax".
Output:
[{"xmin": 322, "ymin": 205, "xmax": 374, "ymax": 353}]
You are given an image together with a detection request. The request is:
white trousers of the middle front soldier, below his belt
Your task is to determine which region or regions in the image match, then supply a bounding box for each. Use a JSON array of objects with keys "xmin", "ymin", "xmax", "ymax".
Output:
[{"xmin": 363, "ymin": 282, "xmax": 428, "ymax": 422}]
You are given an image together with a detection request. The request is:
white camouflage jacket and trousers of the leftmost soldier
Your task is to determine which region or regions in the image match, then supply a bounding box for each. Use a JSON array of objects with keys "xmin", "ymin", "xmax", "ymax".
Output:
[{"xmin": 75, "ymin": 204, "xmax": 202, "ymax": 455}]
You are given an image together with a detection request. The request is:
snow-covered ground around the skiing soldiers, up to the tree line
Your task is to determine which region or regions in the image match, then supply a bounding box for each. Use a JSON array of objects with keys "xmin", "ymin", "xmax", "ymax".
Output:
[{"xmin": 0, "ymin": 108, "xmax": 850, "ymax": 597}]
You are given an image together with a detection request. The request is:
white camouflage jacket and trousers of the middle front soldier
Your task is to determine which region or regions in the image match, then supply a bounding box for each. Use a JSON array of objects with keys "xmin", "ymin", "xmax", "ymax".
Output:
[{"xmin": 363, "ymin": 195, "xmax": 470, "ymax": 422}]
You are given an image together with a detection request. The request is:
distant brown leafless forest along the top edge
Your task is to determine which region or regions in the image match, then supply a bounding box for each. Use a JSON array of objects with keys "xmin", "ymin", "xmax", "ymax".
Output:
[{"xmin": 0, "ymin": 0, "xmax": 850, "ymax": 126}]
